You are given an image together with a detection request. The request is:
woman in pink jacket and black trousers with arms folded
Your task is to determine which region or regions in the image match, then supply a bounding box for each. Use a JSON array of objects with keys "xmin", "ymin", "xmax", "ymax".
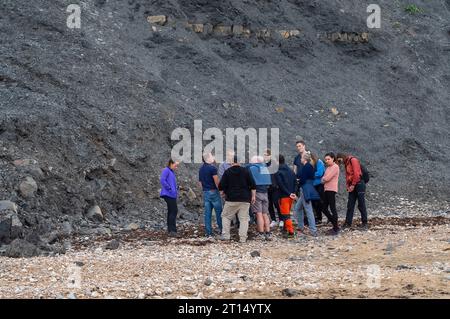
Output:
[{"xmin": 322, "ymin": 152, "xmax": 339, "ymax": 235}]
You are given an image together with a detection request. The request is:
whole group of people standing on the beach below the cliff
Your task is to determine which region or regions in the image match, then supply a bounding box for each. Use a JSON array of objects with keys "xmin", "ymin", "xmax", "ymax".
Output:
[{"xmin": 160, "ymin": 141, "xmax": 368, "ymax": 243}]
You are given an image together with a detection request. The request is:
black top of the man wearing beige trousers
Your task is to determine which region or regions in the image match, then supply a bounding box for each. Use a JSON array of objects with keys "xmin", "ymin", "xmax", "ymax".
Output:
[{"xmin": 219, "ymin": 166, "xmax": 256, "ymax": 203}]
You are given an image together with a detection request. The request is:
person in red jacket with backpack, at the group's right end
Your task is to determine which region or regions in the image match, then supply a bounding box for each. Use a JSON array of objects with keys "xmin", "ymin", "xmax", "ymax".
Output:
[{"xmin": 336, "ymin": 153, "xmax": 368, "ymax": 230}]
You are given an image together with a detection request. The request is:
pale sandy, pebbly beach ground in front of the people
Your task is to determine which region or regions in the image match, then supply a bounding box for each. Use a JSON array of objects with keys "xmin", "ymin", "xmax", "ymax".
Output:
[{"xmin": 0, "ymin": 218, "xmax": 450, "ymax": 299}]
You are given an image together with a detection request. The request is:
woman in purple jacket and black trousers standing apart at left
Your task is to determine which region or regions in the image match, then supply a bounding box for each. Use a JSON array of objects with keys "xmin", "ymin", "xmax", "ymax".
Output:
[{"xmin": 159, "ymin": 159, "xmax": 179, "ymax": 237}]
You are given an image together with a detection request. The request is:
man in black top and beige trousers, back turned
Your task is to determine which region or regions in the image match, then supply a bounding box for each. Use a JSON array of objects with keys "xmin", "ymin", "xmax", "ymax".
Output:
[{"xmin": 219, "ymin": 155, "xmax": 256, "ymax": 243}]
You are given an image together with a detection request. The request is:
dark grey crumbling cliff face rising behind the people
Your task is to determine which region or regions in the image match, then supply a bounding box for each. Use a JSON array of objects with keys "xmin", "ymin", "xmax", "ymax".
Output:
[{"xmin": 0, "ymin": 0, "xmax": 450, "ymax": 255}]
